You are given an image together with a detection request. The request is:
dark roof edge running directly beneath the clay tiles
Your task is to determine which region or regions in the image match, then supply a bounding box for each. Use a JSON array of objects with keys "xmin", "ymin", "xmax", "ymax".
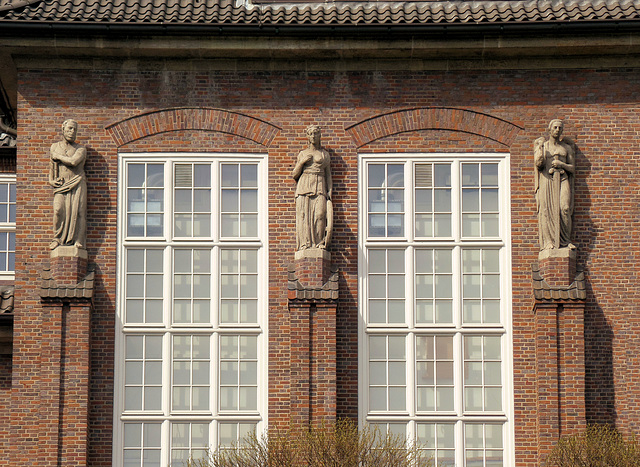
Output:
[{"xmin": 0, "ymin": 19, "xmax": 640, "ymax": 35}]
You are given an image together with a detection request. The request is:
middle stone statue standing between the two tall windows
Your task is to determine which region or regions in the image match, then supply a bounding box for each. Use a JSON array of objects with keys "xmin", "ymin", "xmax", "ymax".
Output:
[{"xmin": 291, "ymin": 125, "xmax": 333, "ymax": 250}]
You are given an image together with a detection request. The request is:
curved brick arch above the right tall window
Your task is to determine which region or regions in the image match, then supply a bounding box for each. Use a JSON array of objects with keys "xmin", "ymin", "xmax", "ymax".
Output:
[{"xmin": 346, "ymin": 107, "xmax": 522, "ymax": 148}]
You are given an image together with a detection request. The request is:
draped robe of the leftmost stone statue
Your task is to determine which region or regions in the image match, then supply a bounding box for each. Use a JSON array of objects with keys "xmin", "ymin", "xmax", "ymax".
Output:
[{"xmin": 51, "ymin": 143, "xmax": 87, "ymax": 246}]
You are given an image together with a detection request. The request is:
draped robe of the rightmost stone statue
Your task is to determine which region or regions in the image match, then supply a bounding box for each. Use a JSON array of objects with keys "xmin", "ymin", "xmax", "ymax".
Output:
[{"xmin": 535, "ymin": 141, "xmax": 574, "ymax": 249}]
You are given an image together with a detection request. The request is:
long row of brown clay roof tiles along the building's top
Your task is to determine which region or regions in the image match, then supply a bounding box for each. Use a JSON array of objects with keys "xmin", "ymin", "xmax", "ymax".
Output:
[{"xmin": 0, "ymin": 0, "xmax": 640, "ymax": 26}]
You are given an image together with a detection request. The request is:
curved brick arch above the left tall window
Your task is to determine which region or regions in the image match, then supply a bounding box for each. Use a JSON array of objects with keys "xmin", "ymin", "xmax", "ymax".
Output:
[{"xmin": 105, "ymin": 107, "xmax": 280, "ymax": 147}]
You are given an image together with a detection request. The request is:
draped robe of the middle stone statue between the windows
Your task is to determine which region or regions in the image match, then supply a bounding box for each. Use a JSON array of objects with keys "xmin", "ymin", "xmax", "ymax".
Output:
[{"xmin": 296, "ymin": 149, "xmax": 330, "ymax": 250}]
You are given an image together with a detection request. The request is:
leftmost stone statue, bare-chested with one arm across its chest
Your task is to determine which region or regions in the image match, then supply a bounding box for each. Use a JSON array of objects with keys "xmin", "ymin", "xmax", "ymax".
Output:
[{"xmin": 49, "ymin": 120, "xmax": 87, "ymax": 250}]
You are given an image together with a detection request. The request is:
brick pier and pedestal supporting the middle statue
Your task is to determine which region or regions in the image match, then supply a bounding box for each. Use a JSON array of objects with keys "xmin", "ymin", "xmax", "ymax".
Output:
[{"xmin": 287, "ymin": 249, "xmax": 339, "ymax": 427}]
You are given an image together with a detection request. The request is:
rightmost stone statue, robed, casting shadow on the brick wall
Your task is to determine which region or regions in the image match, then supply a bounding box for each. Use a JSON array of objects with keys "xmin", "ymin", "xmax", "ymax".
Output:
[{"xmin": 533, "ymin": 119, "xmax": 576, "ymax": 251}]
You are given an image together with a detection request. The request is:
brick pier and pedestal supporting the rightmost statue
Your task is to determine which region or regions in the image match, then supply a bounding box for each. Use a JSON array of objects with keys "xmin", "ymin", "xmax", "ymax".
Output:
[{"xmin": 532, "ymin": 258, "xmax": 587, "ymax": 465}]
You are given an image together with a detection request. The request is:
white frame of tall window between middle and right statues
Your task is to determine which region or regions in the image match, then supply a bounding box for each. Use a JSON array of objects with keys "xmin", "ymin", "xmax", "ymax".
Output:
[{"xmin": 358, "ymin": 153, "xmax": 515, "ymax": 466}]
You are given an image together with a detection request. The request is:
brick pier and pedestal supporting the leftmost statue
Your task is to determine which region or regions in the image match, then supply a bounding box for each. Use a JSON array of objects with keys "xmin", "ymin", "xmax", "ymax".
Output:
[{"xmin": 40, "ymin": 252, "xmax": 95, "ymax": 465}]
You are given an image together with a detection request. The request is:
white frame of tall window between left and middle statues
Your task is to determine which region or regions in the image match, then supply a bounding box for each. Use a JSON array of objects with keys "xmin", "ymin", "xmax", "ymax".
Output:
[{"xmin": 112, "ymin": 152, "xmax": 269, "ymax": 467}]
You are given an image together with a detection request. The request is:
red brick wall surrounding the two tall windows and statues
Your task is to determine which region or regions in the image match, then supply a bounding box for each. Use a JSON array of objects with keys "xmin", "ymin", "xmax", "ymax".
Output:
[{"xmin": 11, "ymin": 69, "xmax": 640, "ymax": 466}]
